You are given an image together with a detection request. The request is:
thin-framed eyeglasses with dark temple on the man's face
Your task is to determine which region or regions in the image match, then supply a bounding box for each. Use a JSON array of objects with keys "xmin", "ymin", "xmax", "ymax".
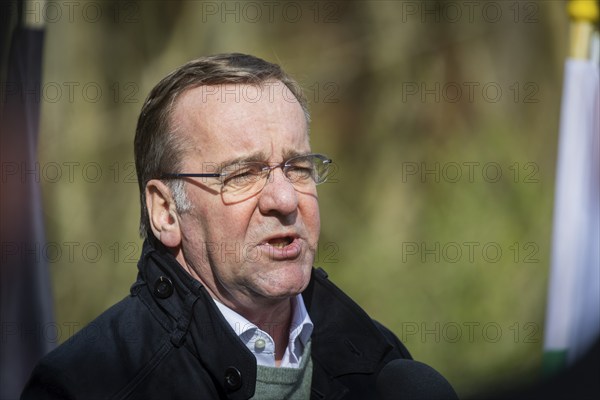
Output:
[{"xmin": 161, "ymin": 154, "xmax": 333, "ymax": 203}]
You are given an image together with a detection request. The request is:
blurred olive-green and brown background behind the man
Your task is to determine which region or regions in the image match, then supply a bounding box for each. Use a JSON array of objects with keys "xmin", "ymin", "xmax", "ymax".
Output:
[{"xmin": 4, "ymin": 0, "xmax": 580, "ymax": 397}]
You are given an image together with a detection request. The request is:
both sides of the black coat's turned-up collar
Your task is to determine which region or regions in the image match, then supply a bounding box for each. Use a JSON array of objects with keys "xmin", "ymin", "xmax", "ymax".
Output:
[{"xmin": 137, "ymin": 239, "xmax": 392, "ymax": 400}]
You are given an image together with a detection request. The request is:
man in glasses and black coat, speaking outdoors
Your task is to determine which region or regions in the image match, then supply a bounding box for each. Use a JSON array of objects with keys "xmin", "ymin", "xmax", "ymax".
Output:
[{"xmin": 22, "ymin": 54, "xmax": 418, "ymax": 399}]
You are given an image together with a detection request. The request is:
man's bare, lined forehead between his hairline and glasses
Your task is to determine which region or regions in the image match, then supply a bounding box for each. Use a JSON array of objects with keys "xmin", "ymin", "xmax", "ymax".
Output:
[{"xmin": 171, "ymin": 81, "xmax": 310, "ymax": 162}]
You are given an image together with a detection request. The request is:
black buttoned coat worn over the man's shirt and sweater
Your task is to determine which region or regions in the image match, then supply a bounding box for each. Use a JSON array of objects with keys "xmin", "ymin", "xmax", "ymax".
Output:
[{"xmin": 21, "ymin": 242, "xmax": 410, "ymax": 400}]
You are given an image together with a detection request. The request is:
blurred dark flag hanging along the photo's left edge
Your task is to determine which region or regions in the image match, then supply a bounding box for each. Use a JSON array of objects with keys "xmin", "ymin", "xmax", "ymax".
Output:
[{"xmin": 0, "ymin": 0, "xmax": 57, "ymax": 399}]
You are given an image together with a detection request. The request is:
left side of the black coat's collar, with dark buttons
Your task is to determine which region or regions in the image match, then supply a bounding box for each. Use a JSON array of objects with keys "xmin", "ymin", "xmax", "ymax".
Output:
[{"xmin": 132, "ymin": 239, "xmax": 256, "ymax": 400}]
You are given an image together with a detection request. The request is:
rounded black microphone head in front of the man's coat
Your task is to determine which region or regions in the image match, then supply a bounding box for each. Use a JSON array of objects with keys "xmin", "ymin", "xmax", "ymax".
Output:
[{"xmin": 376, "ymin": 358, "xmax": 458, "ymax": 400}]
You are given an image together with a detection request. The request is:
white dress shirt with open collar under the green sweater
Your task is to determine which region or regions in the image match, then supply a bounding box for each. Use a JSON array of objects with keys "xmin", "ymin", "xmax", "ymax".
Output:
[{"xmin": 214, "ymin": 294, "xmax": 313, "ymax": 368}]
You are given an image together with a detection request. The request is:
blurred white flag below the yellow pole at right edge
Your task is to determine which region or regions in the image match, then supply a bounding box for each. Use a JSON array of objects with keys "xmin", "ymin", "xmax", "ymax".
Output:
[{"xmin": 544, "ymin": 59, "xmax": 600, "ymax": 371}]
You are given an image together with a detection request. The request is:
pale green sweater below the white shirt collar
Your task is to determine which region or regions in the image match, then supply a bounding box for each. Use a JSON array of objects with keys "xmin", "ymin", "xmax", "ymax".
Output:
[{"xmin": 252, "ymin": 341, "xmax": 312, "ymax": 400}]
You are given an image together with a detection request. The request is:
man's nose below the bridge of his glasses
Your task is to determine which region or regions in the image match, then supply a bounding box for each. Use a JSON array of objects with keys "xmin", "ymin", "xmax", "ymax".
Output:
[{"xmin": 258, "ymin": 168, "xmax": 298, "ymax": 216}]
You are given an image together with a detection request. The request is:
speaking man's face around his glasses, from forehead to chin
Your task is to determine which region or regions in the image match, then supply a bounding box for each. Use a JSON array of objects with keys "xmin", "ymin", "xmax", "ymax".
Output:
[{"xmin": 172, "ymin": 82, "xmax": 320, "ymax": 307}]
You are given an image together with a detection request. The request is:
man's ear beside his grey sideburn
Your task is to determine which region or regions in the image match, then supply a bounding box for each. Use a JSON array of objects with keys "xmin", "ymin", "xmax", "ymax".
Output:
[{"xmin": 145, "ymin": 179, "xmax": 181, "ymax": 248}]
